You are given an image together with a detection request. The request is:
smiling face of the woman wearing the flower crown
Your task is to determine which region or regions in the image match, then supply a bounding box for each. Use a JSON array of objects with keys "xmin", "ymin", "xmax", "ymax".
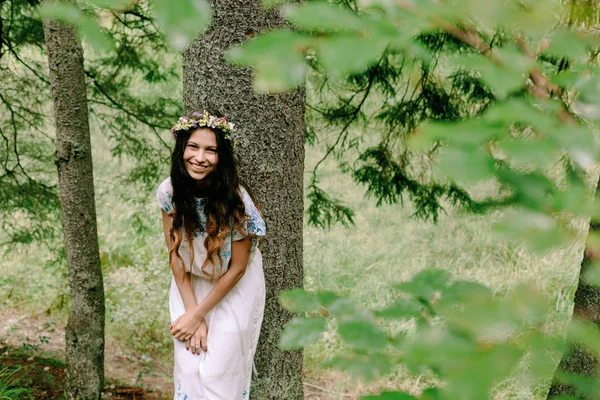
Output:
[{"xmin": 183, "ymin": 128, "xmax": 219, "ymax": 183}]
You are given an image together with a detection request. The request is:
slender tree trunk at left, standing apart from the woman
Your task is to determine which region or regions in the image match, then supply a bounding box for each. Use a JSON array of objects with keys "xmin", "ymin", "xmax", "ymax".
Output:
[{"xmin": 44, "ymin": 3, "xmax": 104, "ymax": 400}]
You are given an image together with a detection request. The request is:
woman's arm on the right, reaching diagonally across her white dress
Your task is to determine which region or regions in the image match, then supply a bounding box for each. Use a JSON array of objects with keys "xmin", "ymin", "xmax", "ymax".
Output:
[{"xmin": 171, "ymin": 238, "xmax": 252, "ymax": 340}]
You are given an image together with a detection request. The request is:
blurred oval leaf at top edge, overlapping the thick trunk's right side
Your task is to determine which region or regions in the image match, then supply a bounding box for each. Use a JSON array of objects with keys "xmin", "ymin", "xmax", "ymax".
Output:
[{"xmin": 282, "ymin": 1, "xmax": 365, "ymax": 32}]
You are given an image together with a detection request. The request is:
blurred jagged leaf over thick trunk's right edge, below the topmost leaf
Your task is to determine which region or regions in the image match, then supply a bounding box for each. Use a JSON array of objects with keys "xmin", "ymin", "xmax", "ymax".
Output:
[{"xmin": 227, "ymin": 30, "xmax": 313, "ymax": 93}]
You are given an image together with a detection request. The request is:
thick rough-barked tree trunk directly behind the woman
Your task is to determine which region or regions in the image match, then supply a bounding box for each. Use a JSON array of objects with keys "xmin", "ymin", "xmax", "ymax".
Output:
[{"xmin": 183, "ymin": 0, "xmax": 304, "ymax": 400}]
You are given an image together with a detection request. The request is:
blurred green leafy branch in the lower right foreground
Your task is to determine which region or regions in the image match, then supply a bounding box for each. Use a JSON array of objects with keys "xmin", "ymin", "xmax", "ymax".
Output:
[{"xmin": 280, "ymin": 269, "xmax": 568, "ymax": 400}]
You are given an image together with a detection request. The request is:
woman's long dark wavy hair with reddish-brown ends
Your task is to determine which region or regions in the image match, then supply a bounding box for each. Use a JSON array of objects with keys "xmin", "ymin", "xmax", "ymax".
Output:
[{"xmin": 169, "ymin": 114, "xmax": 248, "ymax": 281}]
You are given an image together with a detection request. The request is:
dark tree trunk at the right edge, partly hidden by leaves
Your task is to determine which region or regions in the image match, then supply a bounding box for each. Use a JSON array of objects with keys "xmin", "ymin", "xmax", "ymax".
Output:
[{"xmin": 548, "ymin": 180, "xmax": 600, "ymax": 400}]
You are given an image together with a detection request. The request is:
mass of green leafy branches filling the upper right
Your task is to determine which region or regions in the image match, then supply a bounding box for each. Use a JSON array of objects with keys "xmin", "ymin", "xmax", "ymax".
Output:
[{"xmin": 230, "ymin": 1, "xmax": 597, "ymax": 233}]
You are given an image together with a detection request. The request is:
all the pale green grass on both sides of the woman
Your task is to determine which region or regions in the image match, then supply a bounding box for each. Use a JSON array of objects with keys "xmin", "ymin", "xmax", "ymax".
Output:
[{"xmin": 0, "ymin": 123, "xmax": 582, "ymax": 399}]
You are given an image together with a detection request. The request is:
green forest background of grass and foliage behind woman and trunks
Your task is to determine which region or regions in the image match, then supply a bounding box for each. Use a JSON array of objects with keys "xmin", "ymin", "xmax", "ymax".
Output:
[{"xmin": 0, "ymin": 1, "xmax": 598, "ymax": 398}]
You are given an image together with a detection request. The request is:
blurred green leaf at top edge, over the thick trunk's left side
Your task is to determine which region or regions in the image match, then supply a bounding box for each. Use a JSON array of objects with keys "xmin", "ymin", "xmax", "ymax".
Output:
[{"xmin": 152, "ymin": 0, "xmax": 212, "ymax": 50}]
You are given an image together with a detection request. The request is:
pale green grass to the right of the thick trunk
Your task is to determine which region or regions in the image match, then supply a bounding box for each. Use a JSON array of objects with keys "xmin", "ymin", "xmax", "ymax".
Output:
[{"xmin": 304, "ymin": 143, "xmax": 585, "ymax": 399}]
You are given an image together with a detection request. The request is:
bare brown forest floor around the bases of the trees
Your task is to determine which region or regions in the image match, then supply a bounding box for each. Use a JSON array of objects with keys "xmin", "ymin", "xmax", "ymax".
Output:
[{"xmin": 0, "ymin": 309, "xmax": 359, "ymax": 400}]
